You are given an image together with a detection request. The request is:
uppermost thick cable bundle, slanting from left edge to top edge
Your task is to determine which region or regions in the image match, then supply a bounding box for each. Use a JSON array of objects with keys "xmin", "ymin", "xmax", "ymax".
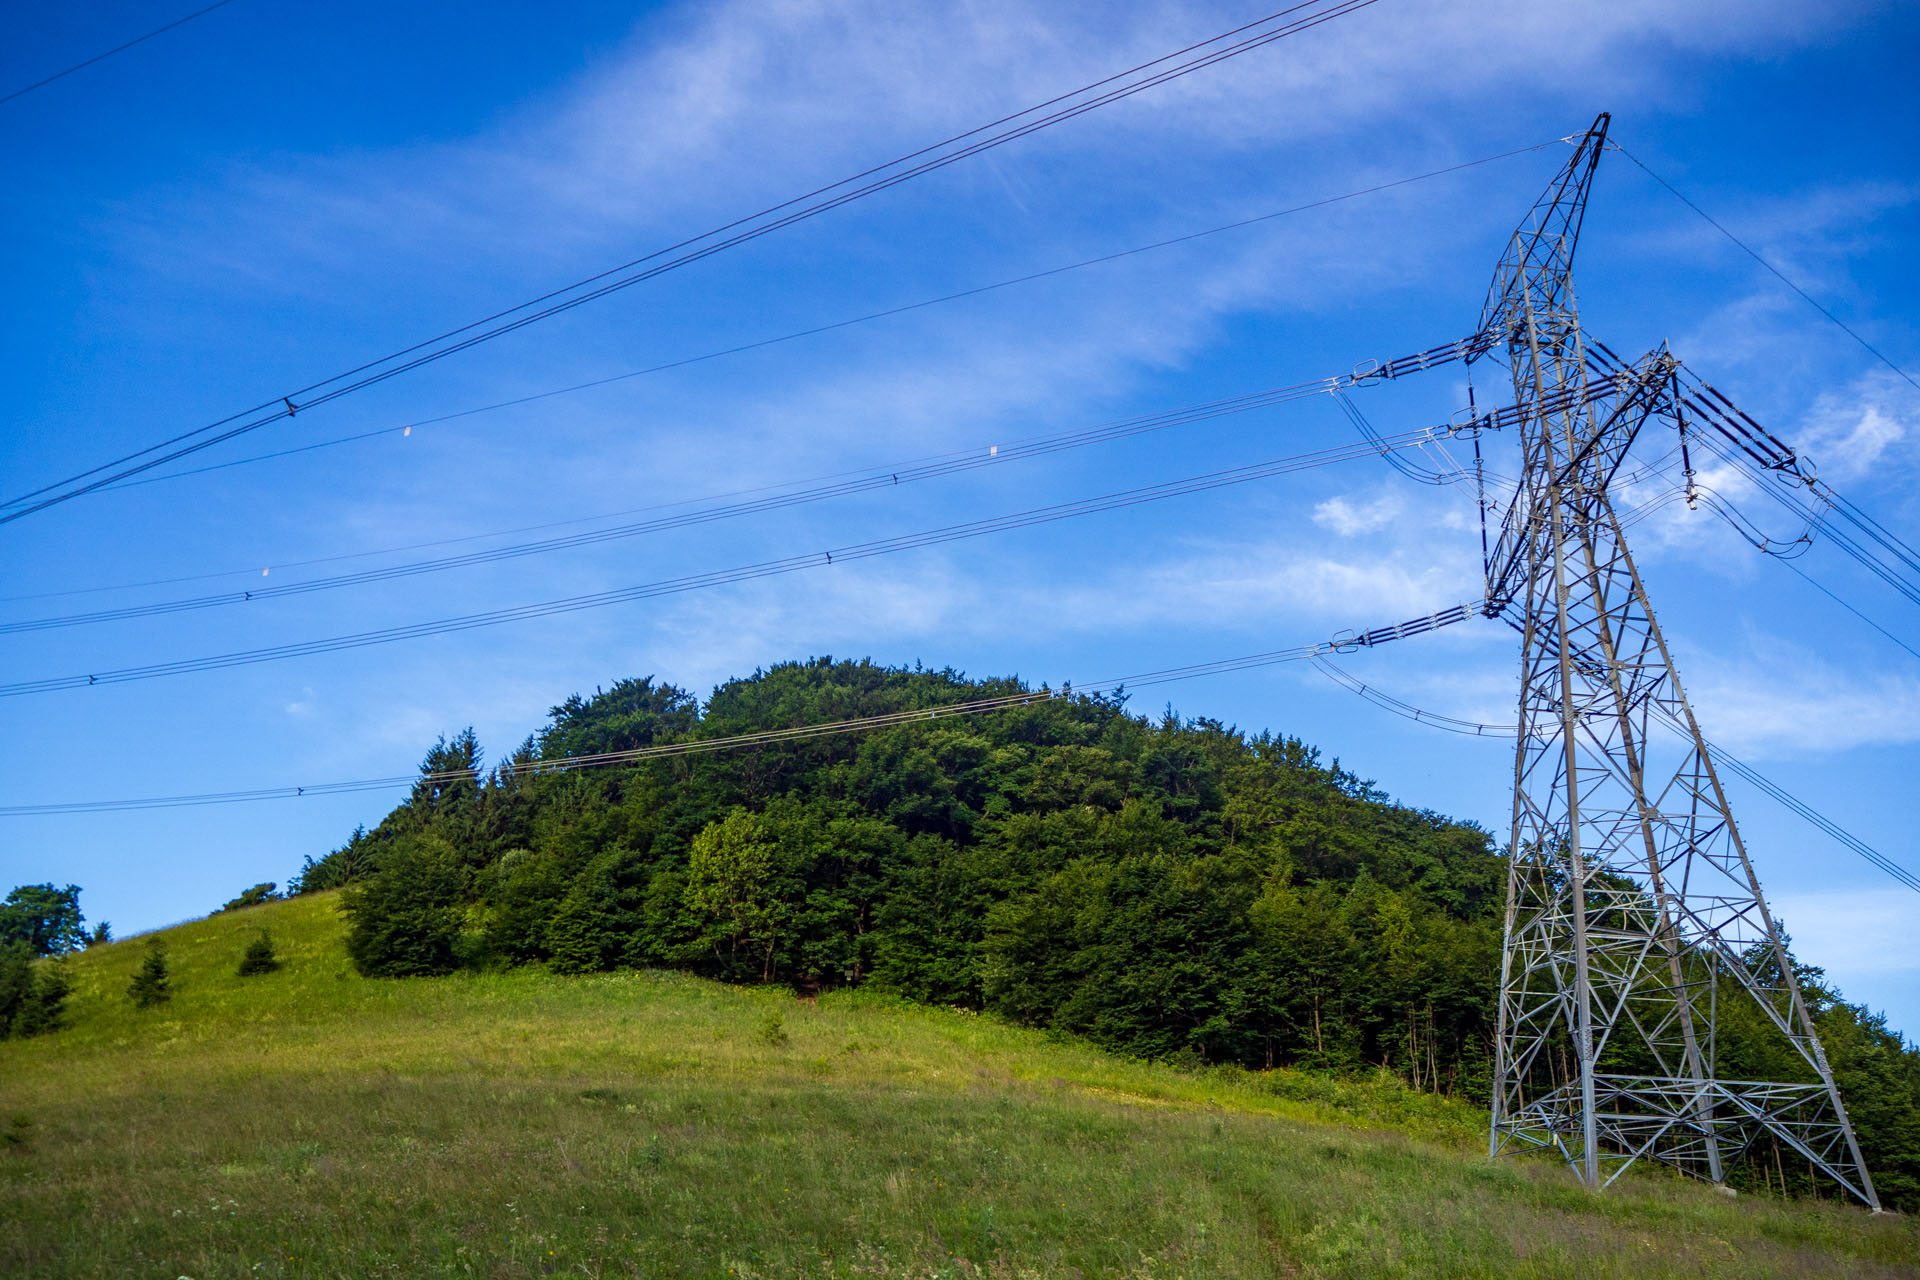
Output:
[{"xmin": 0, "ymin": 0, "xmax": 1377, "ymax": 524}]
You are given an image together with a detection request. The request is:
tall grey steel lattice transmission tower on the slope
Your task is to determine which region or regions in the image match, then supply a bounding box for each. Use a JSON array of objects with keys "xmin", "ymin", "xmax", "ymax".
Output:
[{"xmin": 1478, "ymin": 115, "xmax": 1878, "ymax": 1209}]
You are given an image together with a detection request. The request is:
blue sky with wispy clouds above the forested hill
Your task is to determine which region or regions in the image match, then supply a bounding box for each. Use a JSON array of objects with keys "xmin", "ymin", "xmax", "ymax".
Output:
[{"xmin": 0, "ymin": 0, "xmax": 1920, "ymax": 1029}]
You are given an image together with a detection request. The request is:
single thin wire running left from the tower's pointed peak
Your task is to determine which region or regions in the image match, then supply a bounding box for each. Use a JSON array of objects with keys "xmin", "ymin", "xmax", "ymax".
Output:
[{"xmin": 90, "ymin": 138, "xmax": 1561, "ymax": 491}]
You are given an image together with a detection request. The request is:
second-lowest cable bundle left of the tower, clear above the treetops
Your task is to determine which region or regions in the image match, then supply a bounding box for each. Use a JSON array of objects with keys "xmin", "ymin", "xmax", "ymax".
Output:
[{"xmin": 0, "ymin": 428, "xmax": 1446, "ymax": 697}]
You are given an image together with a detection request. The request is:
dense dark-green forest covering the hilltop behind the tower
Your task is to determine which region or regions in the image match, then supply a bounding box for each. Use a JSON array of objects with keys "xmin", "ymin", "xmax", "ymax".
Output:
[{"xmin": 292, "ymin": 658, "xmax": 1920, "ymax": 1207}]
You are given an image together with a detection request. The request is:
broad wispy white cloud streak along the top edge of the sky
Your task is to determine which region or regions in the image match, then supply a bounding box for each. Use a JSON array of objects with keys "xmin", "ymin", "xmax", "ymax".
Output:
[{"xmin": 108, "ymin": 0, "xmax": 1873, "ymax": 303}]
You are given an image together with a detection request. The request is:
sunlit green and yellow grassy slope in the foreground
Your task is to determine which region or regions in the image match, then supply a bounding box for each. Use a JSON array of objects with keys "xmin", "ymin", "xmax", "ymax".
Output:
[{"xmin": 0, "ymin": 896, "xmax": 1920, "ymax": 1280}]
